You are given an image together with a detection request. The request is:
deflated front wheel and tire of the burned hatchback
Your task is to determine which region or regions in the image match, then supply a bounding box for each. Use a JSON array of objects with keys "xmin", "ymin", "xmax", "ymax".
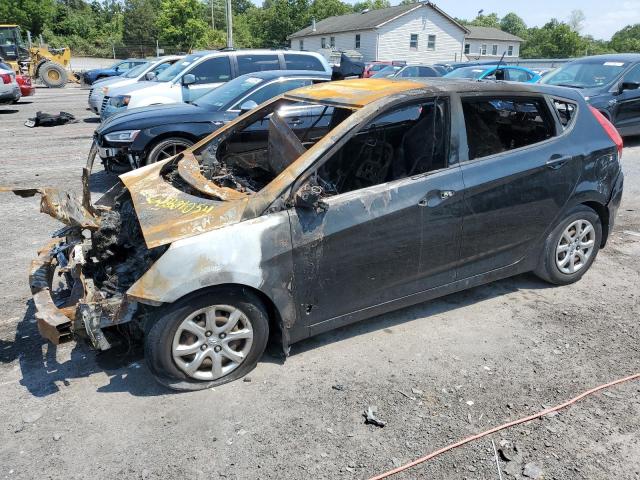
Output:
[{"xmin": 144, "ymin": 288, "xmax": 269, "ymax": 390}]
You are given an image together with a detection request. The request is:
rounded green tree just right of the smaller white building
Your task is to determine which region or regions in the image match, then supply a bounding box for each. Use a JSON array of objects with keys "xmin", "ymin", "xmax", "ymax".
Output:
[{"xmin": 520, "ymin": 18, "xmax": 587, "ymax": 58}]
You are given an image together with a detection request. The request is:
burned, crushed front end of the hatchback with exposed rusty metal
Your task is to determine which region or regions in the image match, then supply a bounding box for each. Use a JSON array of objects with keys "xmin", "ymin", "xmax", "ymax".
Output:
[{"xmin": 13, "ymin": 175, "xmax": 167, "ymax": 350}]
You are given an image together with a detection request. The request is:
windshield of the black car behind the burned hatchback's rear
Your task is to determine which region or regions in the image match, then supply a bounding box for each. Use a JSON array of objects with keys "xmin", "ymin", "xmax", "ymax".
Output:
[{"xmin": 541, "ymin": 61, "xmax": 628, "ymax": 88}]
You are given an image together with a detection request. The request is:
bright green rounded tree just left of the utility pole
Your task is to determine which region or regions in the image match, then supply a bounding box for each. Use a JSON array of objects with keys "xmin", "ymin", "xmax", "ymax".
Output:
[{"xmin": 156, "ymin": 0, "xmax": 207, "ymax": 51}]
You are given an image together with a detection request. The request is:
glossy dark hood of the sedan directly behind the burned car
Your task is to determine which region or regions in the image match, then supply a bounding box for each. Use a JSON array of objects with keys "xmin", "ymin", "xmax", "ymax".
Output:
[{"xmin": 96, "ymin": 103, "xmax": 212, "ymax": 135}]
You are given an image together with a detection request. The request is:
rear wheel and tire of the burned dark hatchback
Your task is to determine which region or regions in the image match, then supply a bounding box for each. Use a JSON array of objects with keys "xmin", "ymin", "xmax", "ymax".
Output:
[{"xmin": 534, "ymin": 205, "xmax": 602, "ymax": 285}]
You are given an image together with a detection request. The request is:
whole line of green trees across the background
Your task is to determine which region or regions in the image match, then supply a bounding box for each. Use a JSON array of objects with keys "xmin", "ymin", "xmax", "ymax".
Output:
[{"xmin": 0, "ymin": 0, "xmax": 640, "ymax": 58}]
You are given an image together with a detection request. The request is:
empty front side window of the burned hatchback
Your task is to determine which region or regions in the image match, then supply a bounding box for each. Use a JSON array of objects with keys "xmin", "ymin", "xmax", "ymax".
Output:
[{"xmin": 316, "ymin": 99, "xmax": 449, "ymax": 195}]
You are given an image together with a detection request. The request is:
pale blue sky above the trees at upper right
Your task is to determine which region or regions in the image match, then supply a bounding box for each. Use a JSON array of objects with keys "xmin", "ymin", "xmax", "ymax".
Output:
[{"xmin": 400, "ymin": 0, "xmax": 640, "ymax": 40}]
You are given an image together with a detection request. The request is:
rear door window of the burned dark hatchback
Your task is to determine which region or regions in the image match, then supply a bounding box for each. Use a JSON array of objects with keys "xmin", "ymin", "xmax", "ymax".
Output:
[{"xmin": 462, "ymin": 98, "xmax": 555, "ymax": 160}]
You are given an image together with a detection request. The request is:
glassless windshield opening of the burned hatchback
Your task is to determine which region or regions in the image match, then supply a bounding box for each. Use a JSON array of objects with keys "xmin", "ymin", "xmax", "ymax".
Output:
[{"xmin": 165, "ymin": 99, "xmax": 352, "ymax": 200}]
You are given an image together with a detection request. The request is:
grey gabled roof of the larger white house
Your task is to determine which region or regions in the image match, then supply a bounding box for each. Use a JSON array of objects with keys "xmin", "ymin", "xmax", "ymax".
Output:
[{"xmin": 288, "ymin": 2, "xmax": 468, "ymax": 38}]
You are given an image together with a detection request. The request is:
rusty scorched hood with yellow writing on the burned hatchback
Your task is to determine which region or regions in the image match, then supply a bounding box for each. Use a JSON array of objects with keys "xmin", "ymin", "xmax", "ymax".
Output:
[{"xmin": 120, "ymin": 156, "xmax": 249, "ymax": 248}]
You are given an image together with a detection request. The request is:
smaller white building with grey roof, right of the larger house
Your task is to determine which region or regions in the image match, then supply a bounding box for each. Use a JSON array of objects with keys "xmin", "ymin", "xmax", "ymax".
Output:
[{"xmin": 464, "ymin": 26, "xmax": 524, "ymax": 61}]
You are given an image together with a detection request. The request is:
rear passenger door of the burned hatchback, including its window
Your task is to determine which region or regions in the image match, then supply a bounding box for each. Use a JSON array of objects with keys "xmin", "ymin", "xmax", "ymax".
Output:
[{"xmin": 459, "ymin": 96, "xmax": 581, "ymax": 279}]
